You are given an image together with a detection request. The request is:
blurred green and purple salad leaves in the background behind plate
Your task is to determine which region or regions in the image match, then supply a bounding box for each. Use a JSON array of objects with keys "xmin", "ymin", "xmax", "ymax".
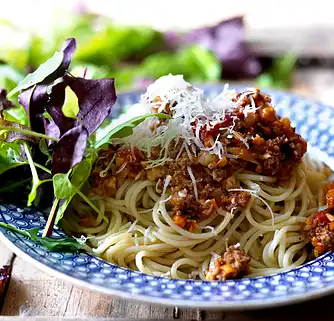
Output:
[{"xmin": 0, "ymin": 10, "xmax": 293, "ymax": 91}]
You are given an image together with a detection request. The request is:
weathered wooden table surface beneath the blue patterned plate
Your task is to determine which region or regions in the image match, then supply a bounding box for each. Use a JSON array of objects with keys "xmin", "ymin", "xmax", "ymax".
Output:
[{"xmin": 0, "ymin": 69, "xmax": 334, "ymax": 321}]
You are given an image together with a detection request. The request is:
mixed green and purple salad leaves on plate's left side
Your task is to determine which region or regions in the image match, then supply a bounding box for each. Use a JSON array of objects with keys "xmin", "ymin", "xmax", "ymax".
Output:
[{"xmin": 0, "ymin": 38, "xmax": 170, "ymax": 250}]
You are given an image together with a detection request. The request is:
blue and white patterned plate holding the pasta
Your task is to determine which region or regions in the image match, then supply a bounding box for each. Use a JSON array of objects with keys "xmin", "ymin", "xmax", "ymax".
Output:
[{"xmin": 0, "ymin": 85, "xmax": 334, "ymax": 310}]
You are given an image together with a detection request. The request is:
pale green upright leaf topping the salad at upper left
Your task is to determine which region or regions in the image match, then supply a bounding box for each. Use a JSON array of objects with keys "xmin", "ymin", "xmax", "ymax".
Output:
[{"xmin": 7, "ymin": 51, "xmax": 64, "ymax": 97}]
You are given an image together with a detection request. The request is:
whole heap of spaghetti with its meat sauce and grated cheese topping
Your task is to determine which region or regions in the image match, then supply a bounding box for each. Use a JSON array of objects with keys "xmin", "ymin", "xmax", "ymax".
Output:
[{"xmin": 63, "ymin": 75, "xmax": 328, "ymax": 280}]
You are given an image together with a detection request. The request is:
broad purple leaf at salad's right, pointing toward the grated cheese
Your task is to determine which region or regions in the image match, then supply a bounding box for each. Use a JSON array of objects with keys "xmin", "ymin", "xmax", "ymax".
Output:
[{"xmin": 66, "ymin": 77, "xmax": 117, "ymax": 136}]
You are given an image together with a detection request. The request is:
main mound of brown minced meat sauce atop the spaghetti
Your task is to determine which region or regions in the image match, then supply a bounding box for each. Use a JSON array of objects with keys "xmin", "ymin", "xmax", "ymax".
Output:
[{"xmin": 92, "ymin": 89, "xmax": 307, "ymax": 231}]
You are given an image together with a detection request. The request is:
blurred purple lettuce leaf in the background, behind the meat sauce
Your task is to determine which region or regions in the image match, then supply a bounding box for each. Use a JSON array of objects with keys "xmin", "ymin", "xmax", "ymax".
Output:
[{"xmin": 165, "ymin": 17, "xmax": 261, "ymax": 79}]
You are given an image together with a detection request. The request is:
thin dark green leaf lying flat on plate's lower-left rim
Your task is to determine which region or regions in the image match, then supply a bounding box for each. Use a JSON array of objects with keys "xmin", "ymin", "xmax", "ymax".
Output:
[{"xmin": 0, "ymin": 222, "xmax": 82, "ymax": 252}]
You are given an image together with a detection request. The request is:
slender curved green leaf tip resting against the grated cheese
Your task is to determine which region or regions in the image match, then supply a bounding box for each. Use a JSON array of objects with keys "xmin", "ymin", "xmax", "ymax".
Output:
[{"xmin": 95, "ymin": 113, "xmax": 171, "ymax": 148}]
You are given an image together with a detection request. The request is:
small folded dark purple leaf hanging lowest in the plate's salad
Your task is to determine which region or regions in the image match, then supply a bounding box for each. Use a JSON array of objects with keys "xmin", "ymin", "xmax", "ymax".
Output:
[{"xmin": 52, "ymin": 125, "xmax": 88, "ymax": 175}]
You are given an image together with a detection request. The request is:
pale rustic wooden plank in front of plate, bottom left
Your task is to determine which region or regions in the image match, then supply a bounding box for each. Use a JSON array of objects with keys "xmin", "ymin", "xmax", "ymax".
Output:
[{"xmin": 0, "ymin": 252, "xmax": 200, "ymax": 320}]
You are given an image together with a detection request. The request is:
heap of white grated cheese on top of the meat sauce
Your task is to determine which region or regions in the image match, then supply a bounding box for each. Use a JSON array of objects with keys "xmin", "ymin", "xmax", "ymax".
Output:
[{"xmin": 116, "ymin": 74, "xmax": 257, "ymax": 168}]
